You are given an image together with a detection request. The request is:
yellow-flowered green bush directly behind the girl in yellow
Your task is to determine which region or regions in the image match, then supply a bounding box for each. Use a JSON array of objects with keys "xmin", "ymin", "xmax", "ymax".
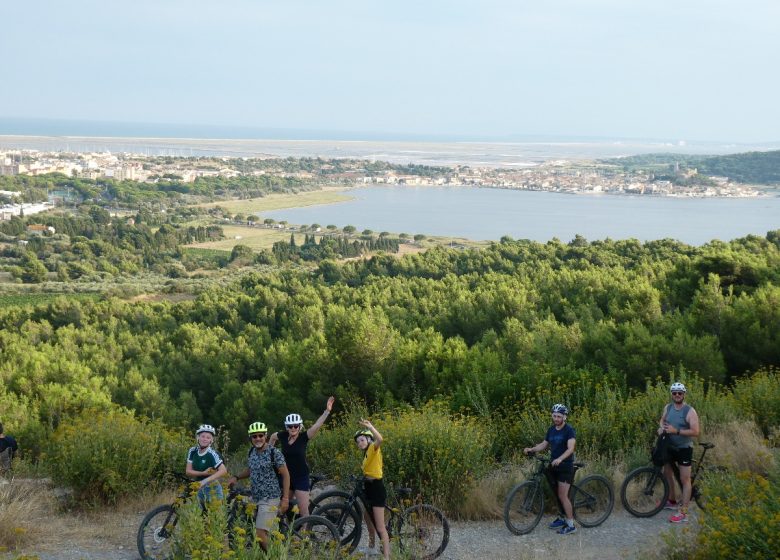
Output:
[{"xmin": 310, "ymin": 404, "xmax": 492, "ymax": 513}]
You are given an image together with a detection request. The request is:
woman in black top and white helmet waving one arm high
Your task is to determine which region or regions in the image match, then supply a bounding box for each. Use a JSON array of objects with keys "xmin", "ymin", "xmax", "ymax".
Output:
[{"xmin": 269, "ymin": 397, "xmax": 336, "ymax": 516}]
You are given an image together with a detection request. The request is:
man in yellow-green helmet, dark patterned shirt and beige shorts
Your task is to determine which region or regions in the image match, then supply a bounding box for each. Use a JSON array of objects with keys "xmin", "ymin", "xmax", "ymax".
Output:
[{"xmin": 228, "ymin": 422, "xmax": 290, "ymax": 550}]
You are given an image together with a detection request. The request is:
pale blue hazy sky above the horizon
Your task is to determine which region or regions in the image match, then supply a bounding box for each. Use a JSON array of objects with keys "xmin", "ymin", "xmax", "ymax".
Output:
[{"xmin": 0, "ymin": 0, "xmax": 780, "ymax": 142}]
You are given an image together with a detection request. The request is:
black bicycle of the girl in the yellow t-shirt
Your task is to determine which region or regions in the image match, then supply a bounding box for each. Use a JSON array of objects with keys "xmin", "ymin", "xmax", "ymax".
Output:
[{"xmin": 312, "ymin": 475, "xmax": 450, "ymax": 560}]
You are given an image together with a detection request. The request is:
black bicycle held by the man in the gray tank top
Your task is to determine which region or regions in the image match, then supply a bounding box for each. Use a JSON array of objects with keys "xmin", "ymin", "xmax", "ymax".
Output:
[{"xmin": 620, "ymin": 442, "xmax": 719, "ymax": 517}]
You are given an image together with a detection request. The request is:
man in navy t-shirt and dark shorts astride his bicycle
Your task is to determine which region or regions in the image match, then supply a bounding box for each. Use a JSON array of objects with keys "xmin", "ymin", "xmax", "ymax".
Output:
[{"xmin": 523, "ymin": 404, "xmax": 577, "ymax": 535}]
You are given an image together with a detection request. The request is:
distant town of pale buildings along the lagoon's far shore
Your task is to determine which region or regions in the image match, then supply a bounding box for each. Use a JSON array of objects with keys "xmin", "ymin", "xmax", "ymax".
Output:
[{"xmin": 0, "ymin": 150, "xmax": 763, "ymax": 219}]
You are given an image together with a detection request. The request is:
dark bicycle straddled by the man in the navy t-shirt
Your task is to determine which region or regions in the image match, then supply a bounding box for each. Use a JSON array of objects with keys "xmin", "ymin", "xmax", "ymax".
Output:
[{"xmin": 504, "ymin": 456, "xmax": 615, "ymax": 535}]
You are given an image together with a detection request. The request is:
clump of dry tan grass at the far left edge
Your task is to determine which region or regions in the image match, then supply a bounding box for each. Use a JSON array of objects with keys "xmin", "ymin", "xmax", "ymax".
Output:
[{"xmin": 0, "ymin": 479, "xmax": 53, "ymax": 549}]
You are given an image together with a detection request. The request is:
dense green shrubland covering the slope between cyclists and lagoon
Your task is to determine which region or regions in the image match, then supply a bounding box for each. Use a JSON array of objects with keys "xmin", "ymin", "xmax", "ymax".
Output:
[{"xmin": 0, "ymin": 232, "xmax": 780, "ymax": 503}]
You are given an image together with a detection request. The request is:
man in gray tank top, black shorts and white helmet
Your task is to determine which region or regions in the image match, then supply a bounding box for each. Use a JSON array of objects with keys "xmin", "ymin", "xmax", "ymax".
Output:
[{"xmin": 658, "ymin": 382, "xmax": 699, "ymax": 523}]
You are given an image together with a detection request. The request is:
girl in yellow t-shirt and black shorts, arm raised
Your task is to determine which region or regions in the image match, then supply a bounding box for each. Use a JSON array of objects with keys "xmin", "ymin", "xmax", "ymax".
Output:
[{"xmin": 355, "ymin": 420, "xmax": 390, "ymax": 560}]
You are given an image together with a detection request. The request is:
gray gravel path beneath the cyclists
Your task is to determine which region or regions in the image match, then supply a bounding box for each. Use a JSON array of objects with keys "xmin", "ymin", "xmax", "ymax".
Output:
[{"xmin": 7, "ymin": 510, "xmax": 693, "ymax": 560}]
